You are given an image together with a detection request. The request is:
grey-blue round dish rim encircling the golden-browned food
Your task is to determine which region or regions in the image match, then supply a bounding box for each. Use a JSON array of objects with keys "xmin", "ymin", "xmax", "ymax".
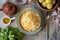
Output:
[{"xmin": 17, "ymin": 7, "xmax": 43, "ymax": 35}]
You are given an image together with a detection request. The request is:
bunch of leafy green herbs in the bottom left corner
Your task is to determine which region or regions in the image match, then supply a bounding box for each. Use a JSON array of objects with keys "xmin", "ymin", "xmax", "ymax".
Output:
[{"xmin": 0, "ymin": 26, "xmax": 24, "ymax": 40}]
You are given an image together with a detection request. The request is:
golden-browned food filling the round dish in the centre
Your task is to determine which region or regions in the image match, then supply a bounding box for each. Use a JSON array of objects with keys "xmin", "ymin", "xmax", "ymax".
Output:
[{"xmin": 19, "ymin": 9, "xmax": 41, "ymax": 32}]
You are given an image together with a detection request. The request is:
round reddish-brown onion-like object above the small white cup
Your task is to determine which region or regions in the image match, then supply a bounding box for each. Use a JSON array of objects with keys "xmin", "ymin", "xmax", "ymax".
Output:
[{"xmin": 0, "ymin": 2, "xmax": 17, "ymax": 16}]
